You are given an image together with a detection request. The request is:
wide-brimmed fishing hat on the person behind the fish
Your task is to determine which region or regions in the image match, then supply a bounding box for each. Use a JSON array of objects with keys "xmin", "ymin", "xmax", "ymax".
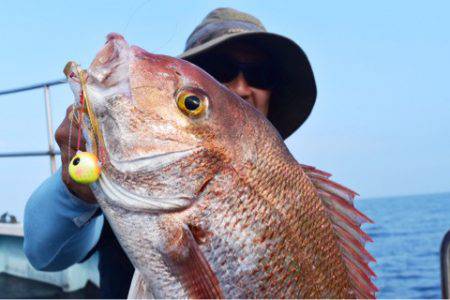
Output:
[{"xmin": 179, "ymin": 8, "xmax": 317, "ymax": 139}]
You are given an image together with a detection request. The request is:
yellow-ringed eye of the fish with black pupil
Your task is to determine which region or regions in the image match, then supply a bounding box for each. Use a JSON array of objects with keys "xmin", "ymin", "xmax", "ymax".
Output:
[{"xmin": 177, "ymin": 88, "xmax": 208, "ymax": 118}]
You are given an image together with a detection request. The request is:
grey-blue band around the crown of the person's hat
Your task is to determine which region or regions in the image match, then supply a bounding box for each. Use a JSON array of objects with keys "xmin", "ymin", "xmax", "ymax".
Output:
[{"xmin": 184, "ymin": 20, "xmax": 265, "ymax": 51}]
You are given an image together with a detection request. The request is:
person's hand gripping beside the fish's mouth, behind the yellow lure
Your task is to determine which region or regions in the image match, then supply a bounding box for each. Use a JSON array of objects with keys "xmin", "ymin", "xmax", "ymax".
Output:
[{"xmin": 55, "ymin": 105, "xmax": 97, "ymax": 203}]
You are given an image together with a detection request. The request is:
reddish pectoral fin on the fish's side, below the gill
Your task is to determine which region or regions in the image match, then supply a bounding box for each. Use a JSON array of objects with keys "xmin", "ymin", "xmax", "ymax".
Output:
[{"xmin": 163, "ymin": 225, "xmax": 223, "ymax": 299}]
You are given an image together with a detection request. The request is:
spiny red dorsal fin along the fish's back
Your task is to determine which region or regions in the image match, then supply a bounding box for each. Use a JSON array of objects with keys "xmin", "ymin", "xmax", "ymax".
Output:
[{"xmin": 302, "ymin": 165, "xmax": 378, "ymax": 298}]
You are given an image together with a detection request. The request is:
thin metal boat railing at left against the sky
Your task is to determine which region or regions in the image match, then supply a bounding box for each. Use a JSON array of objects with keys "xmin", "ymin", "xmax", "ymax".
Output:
[{"xmin": 0, "ymin": 78, "xmax": 67, "ymax": 173}]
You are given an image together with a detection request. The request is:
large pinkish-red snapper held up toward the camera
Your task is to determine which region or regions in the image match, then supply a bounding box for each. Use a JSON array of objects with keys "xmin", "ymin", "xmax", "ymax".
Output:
[{"xmin": 65, "ymin": 34, "xmax": 377, "ymax": 298}]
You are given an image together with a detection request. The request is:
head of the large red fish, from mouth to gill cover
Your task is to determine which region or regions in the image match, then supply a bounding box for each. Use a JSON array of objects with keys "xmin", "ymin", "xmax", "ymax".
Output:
[{"xmin": 65, "ymin": 34, "xmax": 273, "ymax": 210}]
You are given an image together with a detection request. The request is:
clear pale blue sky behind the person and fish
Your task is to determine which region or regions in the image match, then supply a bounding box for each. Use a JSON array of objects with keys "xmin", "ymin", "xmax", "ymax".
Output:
[{"xmin": 0, "ymin": 0, "xmax": 450, "ymax": 216}]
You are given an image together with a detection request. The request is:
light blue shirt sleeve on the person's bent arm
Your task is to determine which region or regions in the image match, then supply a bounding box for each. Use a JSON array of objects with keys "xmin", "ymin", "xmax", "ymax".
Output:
[{"xmin": 24, "ymin": 169, "xmax": 103, "ymax": 271}]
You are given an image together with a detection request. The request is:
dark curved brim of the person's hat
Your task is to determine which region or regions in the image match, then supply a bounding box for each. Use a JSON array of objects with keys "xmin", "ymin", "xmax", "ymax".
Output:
[{"xmin": 178, "ymin": 32, "xmax": 317, "ymax": 139}]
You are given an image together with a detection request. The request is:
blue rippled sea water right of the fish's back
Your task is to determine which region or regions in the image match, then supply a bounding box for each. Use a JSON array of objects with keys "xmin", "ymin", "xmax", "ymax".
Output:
[{"xmin": 356, "ymin": 193, "xmax": 450, "ymax": 298}]
